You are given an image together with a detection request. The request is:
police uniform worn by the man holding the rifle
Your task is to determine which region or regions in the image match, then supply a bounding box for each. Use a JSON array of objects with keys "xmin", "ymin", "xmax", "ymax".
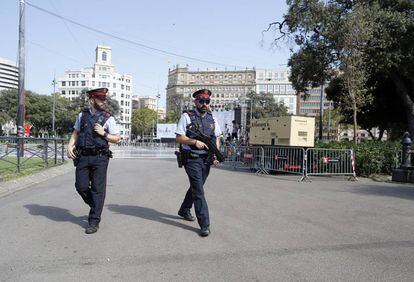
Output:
[{"xmin": 175, "ymin": 91, "xmax": 221, "ymax": 235}]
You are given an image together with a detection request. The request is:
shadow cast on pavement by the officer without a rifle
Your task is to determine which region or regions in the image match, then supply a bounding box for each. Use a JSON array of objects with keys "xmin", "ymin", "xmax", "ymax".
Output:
[{"xmin": 24, "ymin": 204, "xmax": 88, "ymax": 228}]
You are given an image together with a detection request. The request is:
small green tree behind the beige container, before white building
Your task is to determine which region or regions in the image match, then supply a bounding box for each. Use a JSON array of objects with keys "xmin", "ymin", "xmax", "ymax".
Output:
[{"xmin": 246, "ymin": 91, "xmax": 288, "ymax": 127}]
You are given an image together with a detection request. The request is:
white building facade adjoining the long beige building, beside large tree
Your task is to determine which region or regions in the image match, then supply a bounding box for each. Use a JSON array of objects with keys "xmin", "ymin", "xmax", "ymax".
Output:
[{"xmin": 256, "ymin": 68, "xmax": 297, "ymax": 115}]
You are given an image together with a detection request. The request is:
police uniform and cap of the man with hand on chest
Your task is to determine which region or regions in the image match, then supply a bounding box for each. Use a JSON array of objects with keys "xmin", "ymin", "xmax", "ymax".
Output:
[{"xmin": 73, "ymin": 88, "xmax": 119, "ymax": 232}]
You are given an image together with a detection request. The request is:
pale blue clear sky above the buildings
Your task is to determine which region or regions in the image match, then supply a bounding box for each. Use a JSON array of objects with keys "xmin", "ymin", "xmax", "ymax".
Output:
[{"xmin": 0, "ymin": 0, "xmax": 291, "ymax": 106}]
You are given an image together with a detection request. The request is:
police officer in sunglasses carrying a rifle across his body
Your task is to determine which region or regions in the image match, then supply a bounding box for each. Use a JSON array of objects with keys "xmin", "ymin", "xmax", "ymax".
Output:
[{"xmin": 175, "ymin": 89, "xmax": 221, "ymax": 237}]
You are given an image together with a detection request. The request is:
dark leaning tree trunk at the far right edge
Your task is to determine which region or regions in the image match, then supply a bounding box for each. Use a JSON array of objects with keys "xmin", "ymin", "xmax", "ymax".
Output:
[{"xmin": 391, "ymin": 72, "xmax": 414, "ymax": 138}]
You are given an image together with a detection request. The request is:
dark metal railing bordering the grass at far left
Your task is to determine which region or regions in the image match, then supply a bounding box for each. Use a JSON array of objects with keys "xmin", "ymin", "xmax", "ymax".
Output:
[{"xmin": 0, "ymin": 136, "xmax": 66, "ymax": 172}]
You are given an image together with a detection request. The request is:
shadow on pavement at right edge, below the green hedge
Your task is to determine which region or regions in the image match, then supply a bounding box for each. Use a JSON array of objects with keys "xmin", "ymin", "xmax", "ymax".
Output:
[{"xmin": 347, "ymin": 185, "xmax": 414, "ymax": 200}]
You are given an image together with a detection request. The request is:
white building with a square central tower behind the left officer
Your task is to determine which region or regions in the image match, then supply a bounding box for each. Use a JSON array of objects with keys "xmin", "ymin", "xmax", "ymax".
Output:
[{"xmin": 58, "ymin": 45, "xmax": 133, "ymax": 138}]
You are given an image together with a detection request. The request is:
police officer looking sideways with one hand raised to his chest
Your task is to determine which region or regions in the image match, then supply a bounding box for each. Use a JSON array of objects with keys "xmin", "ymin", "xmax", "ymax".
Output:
[{"xmin": 67, "ymin": 88, "xmax": 120, "ymax": 234}]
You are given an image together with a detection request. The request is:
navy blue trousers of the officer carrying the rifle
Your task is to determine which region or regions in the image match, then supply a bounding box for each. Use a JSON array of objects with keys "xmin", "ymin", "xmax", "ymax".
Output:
[{"xmin": 180, "ymin": 158, "xmax": 210, "ymax": 227}]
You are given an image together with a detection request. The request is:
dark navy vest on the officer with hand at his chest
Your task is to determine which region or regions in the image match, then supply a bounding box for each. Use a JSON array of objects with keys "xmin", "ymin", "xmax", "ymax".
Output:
[{"xmin": 76, "ymin": 108, "xmax": 111, "ymax": 148}]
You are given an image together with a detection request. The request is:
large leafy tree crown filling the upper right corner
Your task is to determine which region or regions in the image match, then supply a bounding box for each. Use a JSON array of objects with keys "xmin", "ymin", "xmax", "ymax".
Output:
[{"xmin": 269, "ymin": 0, "xmax": 414, "ymax": 140}]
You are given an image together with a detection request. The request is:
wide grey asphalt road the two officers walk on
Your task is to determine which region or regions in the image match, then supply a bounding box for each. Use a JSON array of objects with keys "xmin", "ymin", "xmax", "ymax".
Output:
[{"xmin": 0, "ymin": 159, "xmax": 414, "ymax": 281}]
